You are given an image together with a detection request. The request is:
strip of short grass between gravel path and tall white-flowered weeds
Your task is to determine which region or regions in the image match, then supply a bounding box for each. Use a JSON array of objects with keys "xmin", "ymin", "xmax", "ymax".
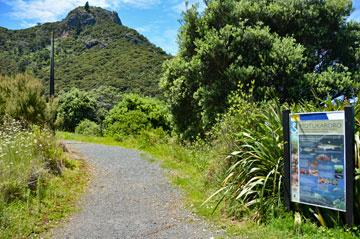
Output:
[{"xmin": 0, "ymin": 160, "xmax": 88, "ymax": 238}]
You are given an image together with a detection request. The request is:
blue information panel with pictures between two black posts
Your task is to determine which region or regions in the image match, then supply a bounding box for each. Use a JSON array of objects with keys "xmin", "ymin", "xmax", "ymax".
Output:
[{"xmin": 290, "ymin": 111, "xmax": 346, "ymax": 211}]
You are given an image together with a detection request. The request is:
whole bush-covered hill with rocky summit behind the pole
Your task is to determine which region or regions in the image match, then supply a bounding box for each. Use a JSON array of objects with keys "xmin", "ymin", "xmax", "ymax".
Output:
[{"xmin": 0, "ymin": 7, "xmax": 169, "ymax": 96}]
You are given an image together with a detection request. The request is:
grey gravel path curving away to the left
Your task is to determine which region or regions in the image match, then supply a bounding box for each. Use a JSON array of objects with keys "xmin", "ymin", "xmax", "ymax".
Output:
[{"xmin": 53, "ymin": 141, "xmax": 223, "ymax": 239}]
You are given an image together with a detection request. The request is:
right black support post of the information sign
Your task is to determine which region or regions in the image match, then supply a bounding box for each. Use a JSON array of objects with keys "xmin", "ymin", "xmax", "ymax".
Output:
[{"xmin": 345, "ymin": 106, "xmax": 355, "ymax": 226}]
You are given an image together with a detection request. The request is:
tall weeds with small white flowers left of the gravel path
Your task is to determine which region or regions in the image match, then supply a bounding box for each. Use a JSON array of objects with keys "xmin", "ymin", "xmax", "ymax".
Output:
[{"xmin": 0, "ymin": 120, "xmax": 64, "ymax": 205}]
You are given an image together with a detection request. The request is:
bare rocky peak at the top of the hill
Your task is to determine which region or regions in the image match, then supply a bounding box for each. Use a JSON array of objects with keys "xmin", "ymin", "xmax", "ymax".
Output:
[{"xmin": 63, "ymin": 7, "xmax": 122, "ymax": 29}]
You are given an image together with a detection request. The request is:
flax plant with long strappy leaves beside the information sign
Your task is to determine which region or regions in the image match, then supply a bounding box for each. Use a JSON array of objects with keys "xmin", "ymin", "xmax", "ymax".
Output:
[{"xmin": 207, "ymin": 100, "xmax": 283, "ymax": 220}]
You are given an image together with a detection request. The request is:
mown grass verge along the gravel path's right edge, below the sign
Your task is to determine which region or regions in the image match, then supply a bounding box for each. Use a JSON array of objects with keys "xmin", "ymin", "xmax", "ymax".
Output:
[{"xmin": 57, "ymin": 132, "xmax": 357, "ymax": 238}]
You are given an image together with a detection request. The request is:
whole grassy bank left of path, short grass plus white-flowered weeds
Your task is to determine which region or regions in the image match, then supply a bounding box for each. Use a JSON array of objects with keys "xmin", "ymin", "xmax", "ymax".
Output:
[{"xmin": 0, "ymin": 125, "xmax": 88, "ymax": 239}]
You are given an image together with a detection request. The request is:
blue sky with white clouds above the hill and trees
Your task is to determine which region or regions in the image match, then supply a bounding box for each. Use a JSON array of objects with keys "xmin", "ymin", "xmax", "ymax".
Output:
[{"xmin": 0, "ymin": 0, "xmax": 360, "ymax": 54}]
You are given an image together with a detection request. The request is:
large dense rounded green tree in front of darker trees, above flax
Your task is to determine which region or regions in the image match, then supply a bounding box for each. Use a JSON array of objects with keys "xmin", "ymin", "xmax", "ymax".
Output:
[{"xmin": 161, "ymin": 23, "xmax": 305, "ymax": 137}]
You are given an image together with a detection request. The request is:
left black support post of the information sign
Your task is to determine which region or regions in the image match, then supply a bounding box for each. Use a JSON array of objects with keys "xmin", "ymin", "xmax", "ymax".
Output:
[{"xmin": 282, "ymin": 110, "xmax": 291, "ymax": 211}]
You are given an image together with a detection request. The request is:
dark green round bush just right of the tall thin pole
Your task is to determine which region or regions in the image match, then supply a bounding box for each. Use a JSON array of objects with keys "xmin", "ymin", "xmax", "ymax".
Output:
[{"xmin": 56, "ymin": 88, "xmax": 97, "ymax": 132}]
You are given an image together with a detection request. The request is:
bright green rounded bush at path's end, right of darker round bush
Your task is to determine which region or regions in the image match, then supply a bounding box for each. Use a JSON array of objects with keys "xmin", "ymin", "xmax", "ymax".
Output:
[{"xmin": 104, "ymin": 94, "xmax": 170, "ymax": 139}]
